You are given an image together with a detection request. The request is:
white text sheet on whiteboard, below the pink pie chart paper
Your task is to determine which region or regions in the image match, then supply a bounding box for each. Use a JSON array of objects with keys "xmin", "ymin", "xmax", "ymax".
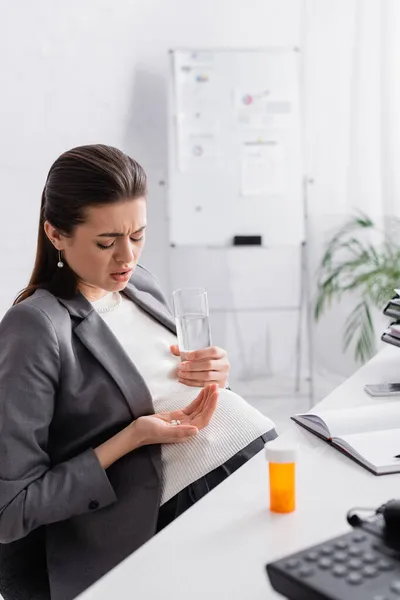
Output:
[{"xmin": 242, "ymin": 140, "xmax": 285, "ymax": 196}]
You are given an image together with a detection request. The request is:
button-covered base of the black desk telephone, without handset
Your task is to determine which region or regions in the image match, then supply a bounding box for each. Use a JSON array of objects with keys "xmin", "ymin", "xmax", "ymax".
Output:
[{"xmin": 266, "ymin": 530, "xmax": 400, "ymax": 600}]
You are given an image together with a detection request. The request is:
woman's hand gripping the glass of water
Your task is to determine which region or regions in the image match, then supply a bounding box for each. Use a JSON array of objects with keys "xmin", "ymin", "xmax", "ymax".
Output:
[{"xmin": 171, "ymin": 346, "xmax": 230, "ymax": 388}]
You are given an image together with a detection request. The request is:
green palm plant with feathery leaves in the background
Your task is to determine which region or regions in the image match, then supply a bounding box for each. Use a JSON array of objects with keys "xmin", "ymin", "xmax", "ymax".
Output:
[{"xmin": 314, "ymin": 213, "xmax": 400, "ymax": 363}]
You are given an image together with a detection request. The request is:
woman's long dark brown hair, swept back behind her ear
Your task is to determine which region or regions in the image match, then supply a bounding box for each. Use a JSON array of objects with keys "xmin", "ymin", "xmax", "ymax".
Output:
[{"xmin": 14, "ymin": 144, "xmax": 147, "ymax": 304}]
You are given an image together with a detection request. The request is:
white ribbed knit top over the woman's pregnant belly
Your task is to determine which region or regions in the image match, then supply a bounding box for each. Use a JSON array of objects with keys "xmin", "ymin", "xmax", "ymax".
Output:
[{"xmin": 92, "ymin": 292, "xmax": 274, "ymax": 504}]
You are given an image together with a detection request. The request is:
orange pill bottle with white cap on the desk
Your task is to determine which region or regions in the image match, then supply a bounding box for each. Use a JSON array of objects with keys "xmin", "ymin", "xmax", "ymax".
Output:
[{"xmin": 265, "ymin": 442, "xmax": 297, "ymax": 513}]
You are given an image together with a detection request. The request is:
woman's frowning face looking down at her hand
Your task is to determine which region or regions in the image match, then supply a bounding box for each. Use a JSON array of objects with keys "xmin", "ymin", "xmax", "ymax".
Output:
[{"xmin": 45, "ymin": 197, "xmax": 146, "ymax": 301}]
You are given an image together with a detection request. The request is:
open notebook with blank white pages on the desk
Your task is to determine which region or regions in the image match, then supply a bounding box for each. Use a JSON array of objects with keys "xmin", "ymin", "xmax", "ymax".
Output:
[{"xmin": 292, "ymin": 401, "xmax": 400, "ymax": 475}]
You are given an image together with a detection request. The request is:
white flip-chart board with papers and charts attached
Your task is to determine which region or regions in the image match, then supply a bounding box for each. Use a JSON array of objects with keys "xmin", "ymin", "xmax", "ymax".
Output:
[{"xmin": 168, "ymin": 47, "xmax": 305, "ymax": 247}]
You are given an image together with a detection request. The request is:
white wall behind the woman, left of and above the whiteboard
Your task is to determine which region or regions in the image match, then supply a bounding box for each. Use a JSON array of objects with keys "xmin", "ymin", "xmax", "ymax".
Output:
[{"xmin": 0, "ymin": 0, "xmax": 300, "ymax": 314}]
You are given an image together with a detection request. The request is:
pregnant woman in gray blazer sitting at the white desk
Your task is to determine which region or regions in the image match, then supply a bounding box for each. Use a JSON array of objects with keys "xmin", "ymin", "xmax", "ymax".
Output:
[{"xmin": 0, "ymin": 145, "xmax": 276, "ymax": 600}]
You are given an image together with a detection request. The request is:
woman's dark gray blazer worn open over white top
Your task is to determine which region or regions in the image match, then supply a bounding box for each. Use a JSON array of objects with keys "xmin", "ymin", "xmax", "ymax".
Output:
[{"xmin": 0, "ymin": 266, "xmax": 175, "ymax": 600}]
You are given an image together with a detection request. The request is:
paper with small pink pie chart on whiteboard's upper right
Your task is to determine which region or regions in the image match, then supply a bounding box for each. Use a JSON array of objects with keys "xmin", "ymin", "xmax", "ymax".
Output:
[{"xmin": 235, "ymin": 90, "xmax": 294, "ymax": 129}]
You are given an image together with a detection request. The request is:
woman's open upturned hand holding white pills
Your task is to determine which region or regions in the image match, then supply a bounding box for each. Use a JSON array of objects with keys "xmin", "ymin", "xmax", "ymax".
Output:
[{"xmin": 130, "ymin": 384, "xmax": 218, "ymax": 446}]
